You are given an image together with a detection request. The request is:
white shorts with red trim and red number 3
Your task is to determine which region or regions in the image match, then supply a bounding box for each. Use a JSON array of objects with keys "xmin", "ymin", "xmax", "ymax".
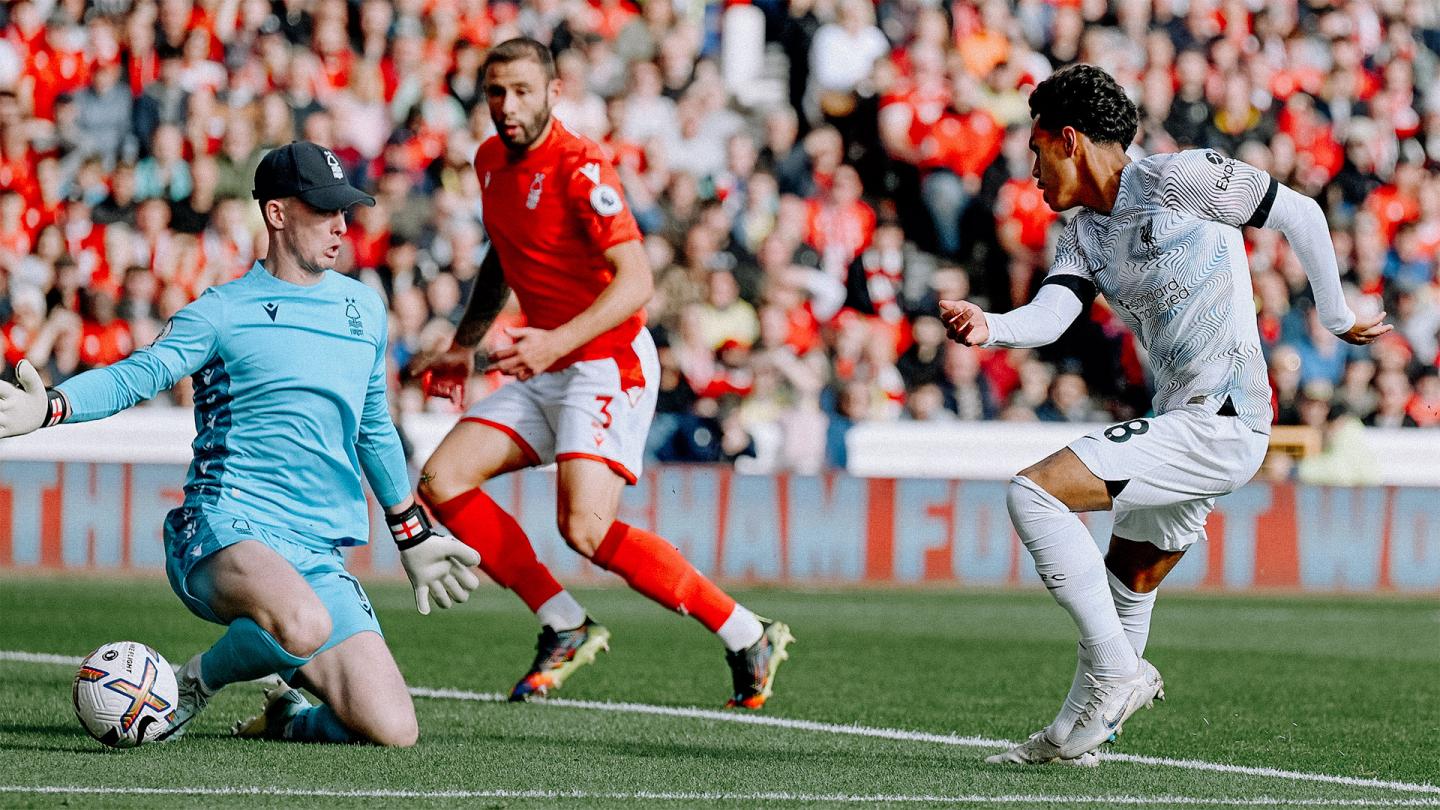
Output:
[{"xmin": 462, "ymin": 329, "xmax": 660, "ymax": 484}]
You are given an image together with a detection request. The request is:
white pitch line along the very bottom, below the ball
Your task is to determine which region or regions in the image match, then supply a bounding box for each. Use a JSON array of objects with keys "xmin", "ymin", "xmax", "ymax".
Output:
[{"xmin": 0, "ymin": 784, "xmax": 1440, "ymax": 807}]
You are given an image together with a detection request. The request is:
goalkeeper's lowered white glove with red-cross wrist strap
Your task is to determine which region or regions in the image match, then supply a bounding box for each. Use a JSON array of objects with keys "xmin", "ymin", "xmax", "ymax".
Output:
[{"xmin": 384, "ymin": 503, "xmax": 480, "ymax": 615}]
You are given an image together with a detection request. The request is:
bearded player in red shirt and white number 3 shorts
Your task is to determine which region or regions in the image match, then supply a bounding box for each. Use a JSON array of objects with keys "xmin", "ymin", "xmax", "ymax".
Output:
[{"xmin": 410, "ymin": 39, "xmax": 792, "ymax": 709}]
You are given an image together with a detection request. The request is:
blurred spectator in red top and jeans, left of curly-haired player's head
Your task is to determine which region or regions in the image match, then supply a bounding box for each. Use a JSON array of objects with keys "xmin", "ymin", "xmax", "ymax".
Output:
[{"xmin": 920, "ymin": 72, "xmax": 1005, "ymax": 257}]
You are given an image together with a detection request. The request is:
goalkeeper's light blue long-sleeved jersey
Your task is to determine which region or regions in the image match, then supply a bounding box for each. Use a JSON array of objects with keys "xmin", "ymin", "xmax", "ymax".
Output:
[{"xmin": 58, "ymin": 262, "xmax": 410, "ymax": 546}]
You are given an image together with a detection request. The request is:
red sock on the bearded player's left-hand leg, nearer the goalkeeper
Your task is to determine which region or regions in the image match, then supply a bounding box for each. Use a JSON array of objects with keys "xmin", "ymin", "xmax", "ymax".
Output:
[{"xmin": 425, "ymin": 487, "xmax": 564, "ymax": 611}]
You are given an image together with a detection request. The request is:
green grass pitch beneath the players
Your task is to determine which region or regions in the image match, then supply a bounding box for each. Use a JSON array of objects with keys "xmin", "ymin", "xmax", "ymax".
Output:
[{"xmin": 0, "ymin": 574, "xmax": 1440, "ymax": 809}]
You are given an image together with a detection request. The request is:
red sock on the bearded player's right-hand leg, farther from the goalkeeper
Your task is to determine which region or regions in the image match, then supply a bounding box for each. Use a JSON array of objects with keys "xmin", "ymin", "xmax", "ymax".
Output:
[{"xmin": 590, "ymin": 520, "xmax": 734, "ymax": 633}]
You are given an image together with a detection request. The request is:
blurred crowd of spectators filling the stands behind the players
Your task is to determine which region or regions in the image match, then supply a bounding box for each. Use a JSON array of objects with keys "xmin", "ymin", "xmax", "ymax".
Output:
[{"xmin": 0, "ymin": 0, "xmax": 1440, "ymax": 471}]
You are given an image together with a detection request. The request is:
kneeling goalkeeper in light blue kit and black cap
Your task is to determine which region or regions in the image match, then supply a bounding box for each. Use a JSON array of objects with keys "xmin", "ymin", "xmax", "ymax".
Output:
[{"xmin": 0, "ymin": 143, "xmax": 480, "ymax": 747}]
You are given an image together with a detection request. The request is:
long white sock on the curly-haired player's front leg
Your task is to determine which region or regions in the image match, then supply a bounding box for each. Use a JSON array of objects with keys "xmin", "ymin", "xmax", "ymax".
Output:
[{"xmin": 1005, "ymin": 476, "xmax": 1140, "ymax": 680}]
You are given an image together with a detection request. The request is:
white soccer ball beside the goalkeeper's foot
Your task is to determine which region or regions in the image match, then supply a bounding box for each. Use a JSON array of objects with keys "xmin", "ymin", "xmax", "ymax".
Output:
[{"xmin": 73, "ymin": 641, "xmax": 180, "ymax": 748}]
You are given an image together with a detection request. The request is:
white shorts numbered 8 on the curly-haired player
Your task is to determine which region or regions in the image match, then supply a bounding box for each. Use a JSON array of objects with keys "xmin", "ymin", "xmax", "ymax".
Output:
[{"xmin": 1070, "ymin": 411, "xmax": 1270, "ymax": 551}]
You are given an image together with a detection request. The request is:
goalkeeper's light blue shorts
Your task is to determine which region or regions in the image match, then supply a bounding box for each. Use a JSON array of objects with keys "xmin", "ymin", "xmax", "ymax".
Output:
[{"xmin": 164, "ymin": 506, "xmax": 383, "ymax": 653}]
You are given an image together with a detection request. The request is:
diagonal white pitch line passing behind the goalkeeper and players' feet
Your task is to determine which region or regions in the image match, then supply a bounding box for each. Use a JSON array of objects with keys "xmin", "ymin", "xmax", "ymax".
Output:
[{"xmin": 11, "ymin": 650, "xmax": 1440, "ymax": 806}]
